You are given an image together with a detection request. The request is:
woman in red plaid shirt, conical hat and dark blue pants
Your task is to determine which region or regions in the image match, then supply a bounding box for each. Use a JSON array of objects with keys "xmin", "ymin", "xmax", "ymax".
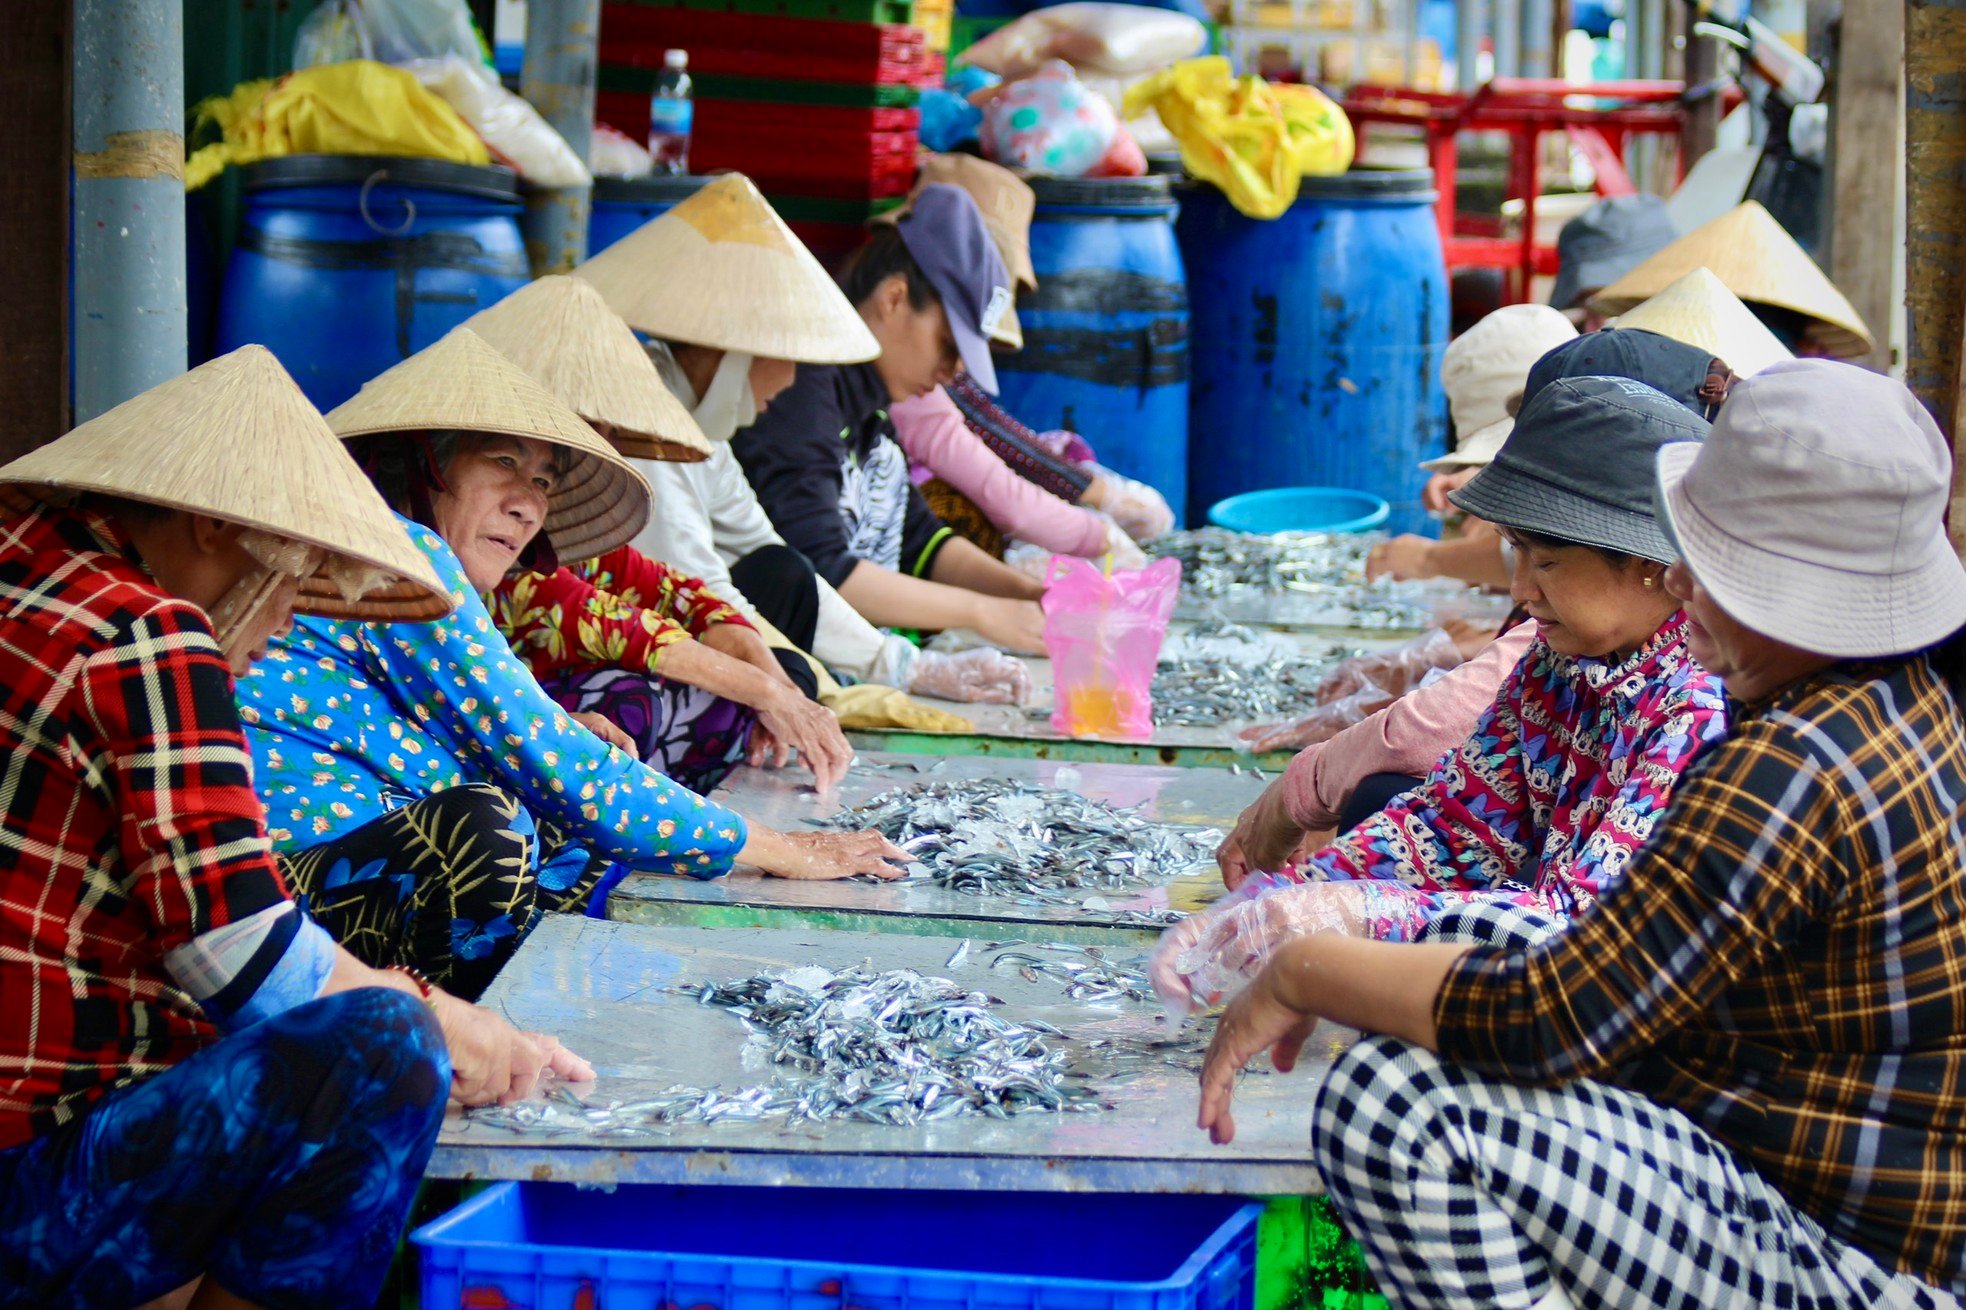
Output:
[{"xmin": 0, "ymin": 346, "xmax": 592, "ymax": 1310}]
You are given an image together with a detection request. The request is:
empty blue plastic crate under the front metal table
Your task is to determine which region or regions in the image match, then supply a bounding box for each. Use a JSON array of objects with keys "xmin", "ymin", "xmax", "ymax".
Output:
[{"xmin": 413, "ymin": 1182, "xmax": 1262, "ymax": 1310}]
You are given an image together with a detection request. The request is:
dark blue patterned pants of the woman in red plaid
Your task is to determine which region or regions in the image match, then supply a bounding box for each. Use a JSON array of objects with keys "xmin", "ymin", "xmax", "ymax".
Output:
[{"xmin": 0, "ymin": 987, "xmax": 450, "ymax": 1310}]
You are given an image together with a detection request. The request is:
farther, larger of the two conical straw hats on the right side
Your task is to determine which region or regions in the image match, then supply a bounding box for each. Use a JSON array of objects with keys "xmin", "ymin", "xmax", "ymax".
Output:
[{"xmin": 1590, "ymin": 201, "xmax": 1872, "ymax": 354}]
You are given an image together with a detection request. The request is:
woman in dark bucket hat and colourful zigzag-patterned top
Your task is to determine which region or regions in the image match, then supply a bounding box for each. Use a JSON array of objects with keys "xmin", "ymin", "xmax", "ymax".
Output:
[{"xmin": 1156, "ymin": 378, "xmax": 1726, "ymax": 993}]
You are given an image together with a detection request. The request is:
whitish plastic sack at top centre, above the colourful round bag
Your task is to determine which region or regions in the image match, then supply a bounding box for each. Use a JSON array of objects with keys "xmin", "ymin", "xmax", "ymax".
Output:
[{"xmin": 961, "ymin": 0, "xmax": 1209, "ymax": 81}]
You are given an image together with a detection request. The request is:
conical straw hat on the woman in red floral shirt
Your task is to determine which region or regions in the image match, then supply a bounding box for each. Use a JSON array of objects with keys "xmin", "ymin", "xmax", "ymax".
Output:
[{"xmin": 464, "ymin": 275, "xmax": 710, "ymax": 464}]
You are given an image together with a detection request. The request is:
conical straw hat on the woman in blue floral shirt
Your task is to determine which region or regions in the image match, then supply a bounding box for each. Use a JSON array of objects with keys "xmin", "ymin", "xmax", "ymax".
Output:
[{"xmin": 328, "ymin": 328, "xmax": 649, "ymax": 561}]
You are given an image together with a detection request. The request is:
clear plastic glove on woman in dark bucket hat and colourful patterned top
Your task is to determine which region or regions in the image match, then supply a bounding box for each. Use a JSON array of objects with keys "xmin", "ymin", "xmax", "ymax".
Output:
[{"xmin": 1146, "ymin": 873, "xmax": 1414, "ymax": 1013}]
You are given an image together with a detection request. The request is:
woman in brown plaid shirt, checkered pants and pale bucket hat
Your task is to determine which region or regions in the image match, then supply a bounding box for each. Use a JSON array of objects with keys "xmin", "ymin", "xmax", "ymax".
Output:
[{"xmin": 1201, "ymin": 360, "xmax": 1966, "ymax": 1310}]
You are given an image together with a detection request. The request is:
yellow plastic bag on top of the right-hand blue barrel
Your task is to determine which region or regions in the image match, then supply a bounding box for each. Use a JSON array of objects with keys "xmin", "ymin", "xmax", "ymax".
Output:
[{"xmin": 1123, "ymin": 55, "xmax": 1357, "ymax": 218}]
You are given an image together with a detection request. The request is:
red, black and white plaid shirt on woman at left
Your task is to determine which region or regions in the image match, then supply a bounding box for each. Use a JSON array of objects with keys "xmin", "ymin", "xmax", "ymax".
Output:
[{"xmin": 0, "ymin": 499, "xmax": 287, "ymax": 1147}]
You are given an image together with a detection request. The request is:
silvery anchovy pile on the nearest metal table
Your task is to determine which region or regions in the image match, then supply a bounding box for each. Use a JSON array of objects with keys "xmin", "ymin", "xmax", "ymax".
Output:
[{"xmin": 470, "ymin": 966, "xmax": 1105, "ymax": 1137}]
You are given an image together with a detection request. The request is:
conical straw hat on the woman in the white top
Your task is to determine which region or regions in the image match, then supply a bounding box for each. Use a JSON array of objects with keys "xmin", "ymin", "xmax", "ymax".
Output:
[{"xmin": 574, "ymin": 173, "xmax": 881, "ymax": 364}]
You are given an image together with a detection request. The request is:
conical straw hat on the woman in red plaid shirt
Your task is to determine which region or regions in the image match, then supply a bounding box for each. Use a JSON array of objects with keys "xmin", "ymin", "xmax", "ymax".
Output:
[{"xmin": 0, "ymin": 346, "xmax": 454, "ymax": 620}]
